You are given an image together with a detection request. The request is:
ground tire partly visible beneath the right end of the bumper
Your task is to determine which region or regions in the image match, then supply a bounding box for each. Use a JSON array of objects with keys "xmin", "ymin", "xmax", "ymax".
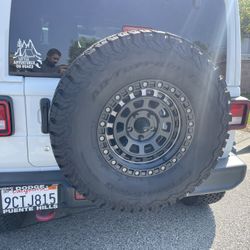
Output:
[{"xmin": 181, "ymin": 192, "xmax": 225, "ymax": 206}]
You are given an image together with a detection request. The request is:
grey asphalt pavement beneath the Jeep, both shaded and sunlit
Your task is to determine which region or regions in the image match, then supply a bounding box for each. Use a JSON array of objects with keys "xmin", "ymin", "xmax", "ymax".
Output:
[{"xmin": 0, "ymin": 132, "xmax": 250, "ymax": 250}]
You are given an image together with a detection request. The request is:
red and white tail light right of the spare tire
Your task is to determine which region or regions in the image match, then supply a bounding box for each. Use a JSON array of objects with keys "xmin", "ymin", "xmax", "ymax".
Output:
[{"xmin": 229, "ymin": 100, "xmax": 250, "ymax": 130}]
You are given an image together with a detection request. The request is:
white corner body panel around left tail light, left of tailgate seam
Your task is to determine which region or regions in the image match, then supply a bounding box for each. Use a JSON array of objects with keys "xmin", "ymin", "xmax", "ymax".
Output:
[{"xmin": 0, "ymin": 0, "xmax": 30, "ymax": 168}]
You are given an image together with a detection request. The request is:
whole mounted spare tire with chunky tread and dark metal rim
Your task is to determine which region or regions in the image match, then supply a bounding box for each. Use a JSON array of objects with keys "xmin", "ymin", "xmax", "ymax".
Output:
[{"xmin": 50, "ymin": 30, "xmax": 230, "ymax": 210}]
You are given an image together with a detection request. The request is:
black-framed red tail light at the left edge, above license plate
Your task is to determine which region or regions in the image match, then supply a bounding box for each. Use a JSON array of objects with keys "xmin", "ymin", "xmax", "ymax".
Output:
[{"xmin": 0, "ymin": 96, "xmax": 14, "ymax": 136}]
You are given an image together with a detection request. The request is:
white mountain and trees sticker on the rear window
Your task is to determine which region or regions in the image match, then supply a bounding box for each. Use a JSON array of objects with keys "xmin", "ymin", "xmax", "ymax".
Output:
[{"xmin": 13, "ymin": 38, "xmax": 42, "ymax": 69}]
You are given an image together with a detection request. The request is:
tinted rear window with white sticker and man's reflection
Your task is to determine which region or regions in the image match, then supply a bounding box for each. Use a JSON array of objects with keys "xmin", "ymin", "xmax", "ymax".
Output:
[{"xmin": 9, "ymin": 0, "xmax": 226, "ymax": 77}]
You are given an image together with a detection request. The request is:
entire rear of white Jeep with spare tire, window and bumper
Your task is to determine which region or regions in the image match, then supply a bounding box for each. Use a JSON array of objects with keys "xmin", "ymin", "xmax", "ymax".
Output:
[{"xmin": 0, "ymin": 0, "xmax": 249, "ymax": 230}]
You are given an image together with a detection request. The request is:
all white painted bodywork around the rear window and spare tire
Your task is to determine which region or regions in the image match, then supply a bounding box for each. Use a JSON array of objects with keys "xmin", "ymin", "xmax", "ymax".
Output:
[{"xmin": 0, "ymin": 0, "xmax": 241, "ymax": 171}]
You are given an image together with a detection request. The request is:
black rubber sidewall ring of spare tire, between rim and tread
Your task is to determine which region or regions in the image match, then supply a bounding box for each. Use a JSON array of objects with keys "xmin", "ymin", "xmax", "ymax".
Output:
[{"xmin": 61, "ymin": 48, "xmax": 225, "ymax": 202}]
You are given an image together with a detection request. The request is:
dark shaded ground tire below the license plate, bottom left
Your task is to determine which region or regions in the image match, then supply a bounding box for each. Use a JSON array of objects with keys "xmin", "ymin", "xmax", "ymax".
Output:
[{"xmin": 0, "ymin": 213, "xmax": 26, "ymax": 232}]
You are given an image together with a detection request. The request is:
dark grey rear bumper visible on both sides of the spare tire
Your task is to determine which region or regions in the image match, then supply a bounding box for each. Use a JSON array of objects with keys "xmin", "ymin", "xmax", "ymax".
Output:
[{"xmin": 0, "ymin": 154, "xmax": 247, "ymax": 207}]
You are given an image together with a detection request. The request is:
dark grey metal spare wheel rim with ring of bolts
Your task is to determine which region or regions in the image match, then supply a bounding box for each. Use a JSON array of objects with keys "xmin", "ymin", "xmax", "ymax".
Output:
[{"xmin": 97, "ymin": 80, "xmax": 195, "ymax": 177}]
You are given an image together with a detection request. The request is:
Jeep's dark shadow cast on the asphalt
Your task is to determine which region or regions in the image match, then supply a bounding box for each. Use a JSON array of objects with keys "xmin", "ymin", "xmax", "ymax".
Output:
[{"xmin": 0, "ymin": 204, "xmax": 216, "ymax": 250}]
